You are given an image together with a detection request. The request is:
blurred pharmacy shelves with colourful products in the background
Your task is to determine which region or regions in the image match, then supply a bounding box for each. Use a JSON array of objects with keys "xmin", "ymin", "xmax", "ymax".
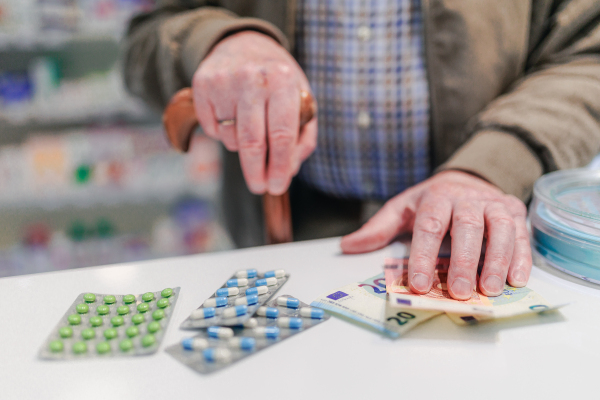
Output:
[{"xmin": 0, "ymin": 0, "xmax": 232, "ymax": 276}]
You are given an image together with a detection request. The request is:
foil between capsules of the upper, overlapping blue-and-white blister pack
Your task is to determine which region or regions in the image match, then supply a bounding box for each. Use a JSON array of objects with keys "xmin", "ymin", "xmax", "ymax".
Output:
[{"xmin": 180, "ymin": 271, "xmax": 290, "ymax": 329}]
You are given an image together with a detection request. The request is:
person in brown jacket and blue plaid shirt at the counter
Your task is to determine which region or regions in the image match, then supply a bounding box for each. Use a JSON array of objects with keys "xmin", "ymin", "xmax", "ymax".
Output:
[{"xmin": 125, "ymin": 0, "xmax": 600, "ymax": 299}]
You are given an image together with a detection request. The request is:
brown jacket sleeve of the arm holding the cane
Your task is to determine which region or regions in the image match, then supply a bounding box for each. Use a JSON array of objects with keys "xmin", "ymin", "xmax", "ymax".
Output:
[{"xmin": 123, "ymin": 0, "xmax": 288, "ymax": 109}]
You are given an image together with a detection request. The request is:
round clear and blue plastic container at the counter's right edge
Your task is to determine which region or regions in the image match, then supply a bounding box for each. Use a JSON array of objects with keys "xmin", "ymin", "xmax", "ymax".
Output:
[{"xmin": 529, "ymin": 169, "xmax": 600, "ymax": 284}]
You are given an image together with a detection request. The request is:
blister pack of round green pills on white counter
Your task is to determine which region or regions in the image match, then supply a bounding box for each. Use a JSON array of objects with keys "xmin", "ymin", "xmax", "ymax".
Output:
[{"xmin": 39, "ymin": 287, "xmax": 180, "ymax": 360}]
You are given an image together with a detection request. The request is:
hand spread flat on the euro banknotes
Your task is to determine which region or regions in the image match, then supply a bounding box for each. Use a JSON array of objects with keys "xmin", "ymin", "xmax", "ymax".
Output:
[{"xmin": 341, "ymin": 171, "xmax": 532, "ymax": 300}]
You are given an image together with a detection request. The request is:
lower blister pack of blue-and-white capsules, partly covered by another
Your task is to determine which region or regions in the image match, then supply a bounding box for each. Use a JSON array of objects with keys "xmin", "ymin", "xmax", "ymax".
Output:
[{"xmin": 166, "ymin": 295, "xmax": 329, "ymax": 374}]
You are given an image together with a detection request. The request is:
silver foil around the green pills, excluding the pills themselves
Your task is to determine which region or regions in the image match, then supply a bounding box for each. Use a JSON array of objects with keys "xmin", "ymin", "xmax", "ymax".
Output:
[{"xmin": 38, "ymin": 287, "xmax": 180, "ymax": 360}]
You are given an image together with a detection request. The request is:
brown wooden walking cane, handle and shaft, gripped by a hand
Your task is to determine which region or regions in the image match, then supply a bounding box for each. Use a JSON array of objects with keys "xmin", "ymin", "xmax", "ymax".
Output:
[{"xmin": 163, "ymin": 88, "xmax": 317, "ymax": 244}]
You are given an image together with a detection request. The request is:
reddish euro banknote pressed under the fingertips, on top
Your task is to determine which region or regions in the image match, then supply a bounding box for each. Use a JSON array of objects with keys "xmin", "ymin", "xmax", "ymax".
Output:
[{"xmin": 384, "ymin": 257, "xmax": 563, "ymax": 324}]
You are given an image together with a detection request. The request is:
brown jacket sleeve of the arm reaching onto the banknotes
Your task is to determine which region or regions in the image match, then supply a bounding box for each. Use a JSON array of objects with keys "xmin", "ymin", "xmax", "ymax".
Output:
[{"xmin": 440, "ymin": 1, "xmax": 600, "ymax": 201}]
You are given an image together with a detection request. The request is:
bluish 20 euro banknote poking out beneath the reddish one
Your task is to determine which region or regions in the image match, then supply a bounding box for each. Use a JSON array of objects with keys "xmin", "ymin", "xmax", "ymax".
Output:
[{"xmin": 311, "ymin": 273, "xmax": 442, "ymax": 338}]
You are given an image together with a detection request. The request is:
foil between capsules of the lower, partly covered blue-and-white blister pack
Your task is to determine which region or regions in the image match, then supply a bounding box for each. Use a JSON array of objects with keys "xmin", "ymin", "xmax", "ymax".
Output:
[{"xmin": 165, "ymin": 295, "xmax": 330, "ymax": 374}]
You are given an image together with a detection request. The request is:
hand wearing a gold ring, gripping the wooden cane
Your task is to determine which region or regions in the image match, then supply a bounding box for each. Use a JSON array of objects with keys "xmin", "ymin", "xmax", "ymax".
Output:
[{"xmin": 192, "ymin": 31, "xmax": 317, "ymax": 195}]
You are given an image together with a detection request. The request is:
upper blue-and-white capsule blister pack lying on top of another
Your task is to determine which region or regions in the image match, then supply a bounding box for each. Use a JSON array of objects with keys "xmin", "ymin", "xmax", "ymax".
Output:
[{"xmin": 181, "ymin": 269, "xmax": 290, "ymax": 329}]
